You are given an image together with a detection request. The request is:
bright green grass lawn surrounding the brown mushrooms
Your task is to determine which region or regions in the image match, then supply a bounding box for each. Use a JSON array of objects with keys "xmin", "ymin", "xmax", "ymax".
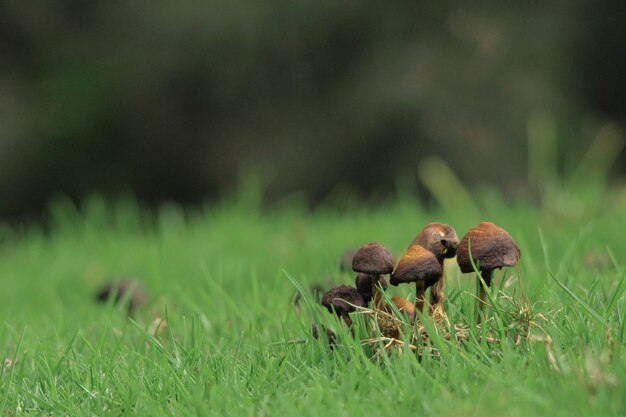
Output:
[{"xmin": 0, "ymin": 187, "xmax": 626, "ymax": 417}]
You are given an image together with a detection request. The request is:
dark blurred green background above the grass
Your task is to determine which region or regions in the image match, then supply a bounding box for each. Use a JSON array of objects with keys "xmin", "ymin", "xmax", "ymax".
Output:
[{"xmin": 0, "ymin": 0, "xmax": 626, "ymax": 219}]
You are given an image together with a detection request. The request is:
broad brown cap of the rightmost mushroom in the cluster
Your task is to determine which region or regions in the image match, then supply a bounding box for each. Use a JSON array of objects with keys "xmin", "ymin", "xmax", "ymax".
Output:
[{"xmin": 456, "ymin": 222, "xmax": 520, "ymax": 273}]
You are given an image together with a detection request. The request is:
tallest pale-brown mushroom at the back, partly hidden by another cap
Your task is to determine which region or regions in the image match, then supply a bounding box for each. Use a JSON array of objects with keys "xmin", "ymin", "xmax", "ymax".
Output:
[{"xmin": 409, "ymin": 223, "xmax": 459, "ymax": 314}]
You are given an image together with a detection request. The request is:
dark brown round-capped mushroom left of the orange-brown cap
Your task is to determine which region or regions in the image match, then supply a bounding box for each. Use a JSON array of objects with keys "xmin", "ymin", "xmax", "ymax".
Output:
[{"xmin": 352, "ymin": 242, "xmax": 394, "ymax": 309}]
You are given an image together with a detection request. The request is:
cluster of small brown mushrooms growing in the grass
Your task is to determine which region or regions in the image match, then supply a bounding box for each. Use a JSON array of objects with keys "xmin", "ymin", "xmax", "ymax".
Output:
[{"xmin": 322, "ymin": 222, "xmax": 520, "ymax": 337}]
